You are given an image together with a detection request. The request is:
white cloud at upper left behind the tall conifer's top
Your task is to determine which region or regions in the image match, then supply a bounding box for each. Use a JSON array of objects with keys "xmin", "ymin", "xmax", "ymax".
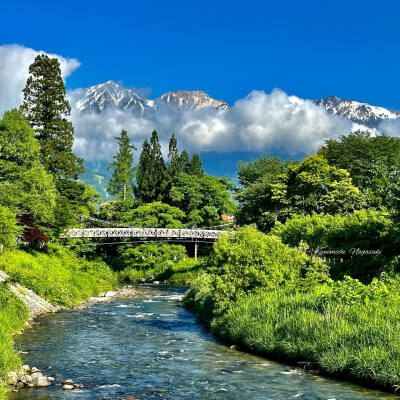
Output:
[{"xmin": 0, "ymin": 44, "xmax": 80, "ymax": 115}]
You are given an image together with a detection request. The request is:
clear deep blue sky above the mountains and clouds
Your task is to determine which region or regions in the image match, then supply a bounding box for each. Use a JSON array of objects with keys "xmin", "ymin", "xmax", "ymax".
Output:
[{"xmin": 0, "ymin": 0, "xmax": 400, "ymax": 109}]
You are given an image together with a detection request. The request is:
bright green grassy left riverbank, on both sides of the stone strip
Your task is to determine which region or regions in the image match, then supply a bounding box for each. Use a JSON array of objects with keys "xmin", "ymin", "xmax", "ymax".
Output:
[{"xmin": 0, "ymin": 245, "xmax": 117, "ymax": 399}]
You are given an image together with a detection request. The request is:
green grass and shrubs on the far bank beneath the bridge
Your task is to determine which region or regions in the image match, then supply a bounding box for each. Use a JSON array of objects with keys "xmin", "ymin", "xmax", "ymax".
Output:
[{"xmin": 118, "ymin": 257, "xmax": 202, "ymax": 286}]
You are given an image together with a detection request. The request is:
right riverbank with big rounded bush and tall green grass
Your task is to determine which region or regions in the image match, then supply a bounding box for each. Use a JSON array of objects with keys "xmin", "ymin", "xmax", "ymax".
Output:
[{"xmin": 184, "ymin": 228, "xmax": 400, "ymax": 391}]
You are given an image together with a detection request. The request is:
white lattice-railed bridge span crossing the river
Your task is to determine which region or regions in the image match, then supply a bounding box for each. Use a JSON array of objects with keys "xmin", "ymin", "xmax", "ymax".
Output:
[{"xmin": 62, "ymin": 227, "xmax": 228, "ymax": 241}]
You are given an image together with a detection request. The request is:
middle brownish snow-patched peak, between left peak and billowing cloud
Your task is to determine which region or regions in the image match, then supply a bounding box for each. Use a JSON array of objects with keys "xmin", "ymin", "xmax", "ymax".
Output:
[{"xmin": 159, "ymin": 90, "xmax": 229, "ymax": 110}]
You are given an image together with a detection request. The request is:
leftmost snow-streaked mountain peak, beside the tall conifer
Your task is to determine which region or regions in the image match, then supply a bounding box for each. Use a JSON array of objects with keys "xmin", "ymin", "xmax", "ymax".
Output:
[{"xmin": 76, "ymin": 81, "xmax": 154, "ymax": 113}]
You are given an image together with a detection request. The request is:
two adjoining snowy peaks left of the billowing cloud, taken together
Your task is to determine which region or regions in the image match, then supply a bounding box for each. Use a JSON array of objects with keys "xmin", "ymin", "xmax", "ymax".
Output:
[{"xmin": 75, "ymin": 81, "xmax": 229, "ymax": 113}]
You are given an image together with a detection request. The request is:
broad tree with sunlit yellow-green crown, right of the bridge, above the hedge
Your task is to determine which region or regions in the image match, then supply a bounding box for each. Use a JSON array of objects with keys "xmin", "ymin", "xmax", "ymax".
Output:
[{"xmin": 237, "ymin": 156, "xmax": 364, "ymax": 230}]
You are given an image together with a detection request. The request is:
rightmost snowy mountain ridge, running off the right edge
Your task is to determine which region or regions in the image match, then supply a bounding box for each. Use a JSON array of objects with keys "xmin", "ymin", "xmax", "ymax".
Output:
[{"xmin": 315, "ymin": 96, "xmax": 400, "ymax": 128}]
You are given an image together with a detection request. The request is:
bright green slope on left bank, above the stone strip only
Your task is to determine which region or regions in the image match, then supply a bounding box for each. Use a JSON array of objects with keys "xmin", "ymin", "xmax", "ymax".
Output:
[{"xmin": 0, "ymin": 245, "xmax": 116, "ymax": 307}]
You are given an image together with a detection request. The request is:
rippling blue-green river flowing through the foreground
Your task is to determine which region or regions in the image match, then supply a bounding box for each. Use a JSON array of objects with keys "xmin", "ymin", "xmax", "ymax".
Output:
[{"xmin": 10, "ymin": 286, "xmax": 399, "ymax": 400}]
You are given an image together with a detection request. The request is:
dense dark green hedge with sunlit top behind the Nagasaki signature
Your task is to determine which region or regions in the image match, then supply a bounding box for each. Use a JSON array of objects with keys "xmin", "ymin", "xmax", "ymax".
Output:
[{"xmin": 272, "ymin": 210, "xmax": 398, "ymax": 282}]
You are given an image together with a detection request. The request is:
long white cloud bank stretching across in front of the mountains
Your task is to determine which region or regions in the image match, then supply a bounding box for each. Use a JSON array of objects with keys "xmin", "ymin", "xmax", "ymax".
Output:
[{"xmin": 70, "ymin": 89, "xmax": 366, "ymax": 160}]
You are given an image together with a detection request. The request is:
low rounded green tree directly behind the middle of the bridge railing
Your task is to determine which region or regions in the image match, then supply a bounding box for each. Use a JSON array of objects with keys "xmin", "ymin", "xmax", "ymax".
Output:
[{"xmin": 122, "ymin": 202, "xmax": 185, "ymax": 228}]
